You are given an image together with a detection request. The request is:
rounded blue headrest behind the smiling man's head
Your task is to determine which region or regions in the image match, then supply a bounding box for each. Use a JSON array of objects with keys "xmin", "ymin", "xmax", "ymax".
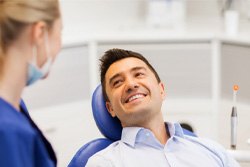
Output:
[{"xmin": 92, "ymin": 85, "xmax": 122, "ymax": 141}]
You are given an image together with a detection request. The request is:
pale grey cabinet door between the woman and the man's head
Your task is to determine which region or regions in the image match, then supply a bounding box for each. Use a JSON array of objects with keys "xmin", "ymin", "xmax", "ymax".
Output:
[{"xmin": 23, "ymin": 45, "xmax": 91, "ymax": 109}]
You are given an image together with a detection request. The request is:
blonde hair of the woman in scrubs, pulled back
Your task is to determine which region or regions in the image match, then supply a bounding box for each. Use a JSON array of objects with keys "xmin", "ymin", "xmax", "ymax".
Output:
[{"xmin": 0, "ymin": 0, "xmax": 60, "ymax": 67}]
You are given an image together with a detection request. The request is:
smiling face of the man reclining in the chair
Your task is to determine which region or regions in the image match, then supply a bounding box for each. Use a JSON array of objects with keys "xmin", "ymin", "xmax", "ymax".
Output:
[{"xmin": 105, "ymin": 57, "xmax": 165, "ymax": 127}]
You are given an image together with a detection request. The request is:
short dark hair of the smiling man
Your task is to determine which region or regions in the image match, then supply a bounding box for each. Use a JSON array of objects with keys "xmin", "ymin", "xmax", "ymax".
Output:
[{"xmin": 99, "ymin": 48, "xmax": 161, "ymax": 101}]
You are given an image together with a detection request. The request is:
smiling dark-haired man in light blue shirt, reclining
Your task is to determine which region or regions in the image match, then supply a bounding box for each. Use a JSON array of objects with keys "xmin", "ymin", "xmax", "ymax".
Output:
[{"xmin": 86, "ymin": 49, "xmax": 239, "ymax": 167}]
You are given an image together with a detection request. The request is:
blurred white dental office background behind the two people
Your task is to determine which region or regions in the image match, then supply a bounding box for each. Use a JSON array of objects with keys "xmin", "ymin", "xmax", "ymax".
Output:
[{"xmin": 23, "ymin": 0, "xmax": 250, "ymax": 167}]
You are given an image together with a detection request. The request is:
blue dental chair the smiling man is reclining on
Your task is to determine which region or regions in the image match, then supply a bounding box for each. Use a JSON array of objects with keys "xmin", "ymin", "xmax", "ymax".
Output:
[{"xmin": 68, "ymin": 85, "xmax": 196, "ymax": 167}]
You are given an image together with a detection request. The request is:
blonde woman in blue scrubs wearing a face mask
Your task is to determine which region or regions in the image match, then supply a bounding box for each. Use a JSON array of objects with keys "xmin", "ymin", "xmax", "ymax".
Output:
[{"xmin": 0, "ymin": 0, "xmax": 62, "ymax": 167}]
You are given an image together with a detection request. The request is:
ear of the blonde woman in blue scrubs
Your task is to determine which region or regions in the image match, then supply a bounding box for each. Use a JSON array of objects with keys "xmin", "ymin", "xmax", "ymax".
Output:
[{"xmin": 32, "ymin": 21, "xmax": 47, "ymax": 45}]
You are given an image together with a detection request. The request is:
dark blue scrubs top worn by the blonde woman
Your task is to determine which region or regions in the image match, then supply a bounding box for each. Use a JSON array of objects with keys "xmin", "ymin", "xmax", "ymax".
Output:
[{"xmin": 0, "ymin": 98, "xmax": 57, "ymax": 167}]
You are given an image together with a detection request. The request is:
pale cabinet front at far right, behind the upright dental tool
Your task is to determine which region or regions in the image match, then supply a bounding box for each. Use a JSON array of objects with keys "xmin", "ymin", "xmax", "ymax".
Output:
[{"xmin": 219, "ymin": 43, "xmax": 250, "ymax": 150}]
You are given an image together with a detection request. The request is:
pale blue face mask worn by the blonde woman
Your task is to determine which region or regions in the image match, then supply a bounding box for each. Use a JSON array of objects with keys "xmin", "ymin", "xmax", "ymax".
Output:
[{"xmin": 26, "ymin": 33, "xmax": 52, "ymax": 86}]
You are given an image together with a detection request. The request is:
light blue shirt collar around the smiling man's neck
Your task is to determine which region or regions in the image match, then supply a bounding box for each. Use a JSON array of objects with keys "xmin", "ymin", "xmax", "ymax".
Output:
[{"xmin": 121, "ymin": 122, "xmax": 184, "ymax": 147}]
